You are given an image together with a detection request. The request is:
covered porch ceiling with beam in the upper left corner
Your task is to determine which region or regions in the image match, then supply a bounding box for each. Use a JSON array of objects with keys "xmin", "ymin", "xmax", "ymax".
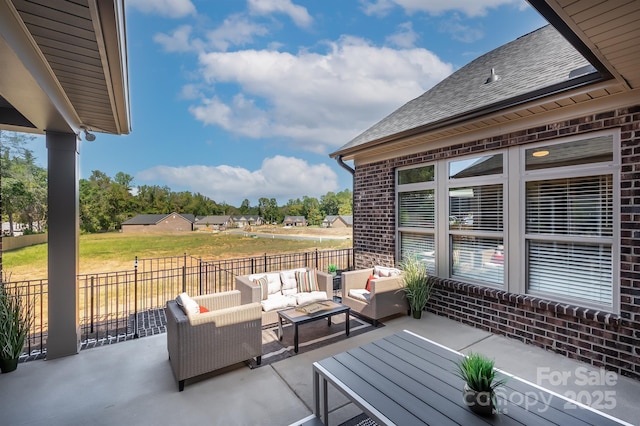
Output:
[{"xmin": 0, "ymin": 0, "xmax": 130, "ymax": 134}]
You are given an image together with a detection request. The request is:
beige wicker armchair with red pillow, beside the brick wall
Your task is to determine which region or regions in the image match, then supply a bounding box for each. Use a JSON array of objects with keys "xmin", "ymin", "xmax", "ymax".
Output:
[{"xmin": 342, "ymin": 266, "xmax": 409, "ymax": 325}]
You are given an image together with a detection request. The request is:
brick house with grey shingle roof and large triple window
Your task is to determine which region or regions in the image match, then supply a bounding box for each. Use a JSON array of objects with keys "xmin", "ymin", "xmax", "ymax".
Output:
[{"xmin": 331, "ymin": 14, "xmax": 640, "ymax": 379}]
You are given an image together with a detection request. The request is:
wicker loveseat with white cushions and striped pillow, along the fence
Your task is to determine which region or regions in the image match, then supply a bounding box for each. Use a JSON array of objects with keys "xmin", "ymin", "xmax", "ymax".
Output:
[{"xmin": 236, "ymin": 268, "xmax": 333, "ymax": 326}]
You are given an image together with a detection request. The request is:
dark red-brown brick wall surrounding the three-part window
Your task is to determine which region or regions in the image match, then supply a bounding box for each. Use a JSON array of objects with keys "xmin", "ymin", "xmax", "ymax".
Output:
[{"xmin": 353, "ymin": 105, "xmax": 640, "ymax": 379}]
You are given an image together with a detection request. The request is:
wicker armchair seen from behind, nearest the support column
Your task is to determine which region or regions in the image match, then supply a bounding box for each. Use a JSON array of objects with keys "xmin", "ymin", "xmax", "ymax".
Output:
[{"xmin": 166, "ymin": 290, "xmax": 262, "ymax": 391}]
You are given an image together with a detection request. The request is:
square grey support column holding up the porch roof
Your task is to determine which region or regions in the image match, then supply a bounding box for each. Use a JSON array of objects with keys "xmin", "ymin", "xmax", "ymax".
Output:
[{"xmin": 46, "ymin": 132, "xmax": 80, "ymax": 359}]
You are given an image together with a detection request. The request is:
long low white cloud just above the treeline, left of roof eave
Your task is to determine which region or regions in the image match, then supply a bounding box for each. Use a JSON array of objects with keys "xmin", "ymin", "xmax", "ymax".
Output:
[{"xmin": 135, "ymin": 155, "xmax": 338, "ymax": 205}]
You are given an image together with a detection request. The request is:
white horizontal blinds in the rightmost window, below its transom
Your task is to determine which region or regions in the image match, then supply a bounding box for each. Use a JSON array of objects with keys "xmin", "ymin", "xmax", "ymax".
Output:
[{"xmin": 526, "ymin": 175, "xmax": 613, "ymax": 305}]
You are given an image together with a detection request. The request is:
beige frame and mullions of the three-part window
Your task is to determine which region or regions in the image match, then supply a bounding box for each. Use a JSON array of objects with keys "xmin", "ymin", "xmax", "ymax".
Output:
[{"xmin": 395, "ymin": 129, "xmax": 621, "ymax": 314}]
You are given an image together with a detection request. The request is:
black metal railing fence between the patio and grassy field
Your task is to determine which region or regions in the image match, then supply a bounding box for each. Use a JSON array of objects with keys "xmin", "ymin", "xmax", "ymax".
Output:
[{"xmin": 3, "ymin": 249, "xmax": 353, "ymax": 360}]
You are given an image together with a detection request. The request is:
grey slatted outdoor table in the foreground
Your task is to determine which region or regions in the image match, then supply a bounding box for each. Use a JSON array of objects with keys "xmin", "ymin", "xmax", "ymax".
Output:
[{"xmin": 313, "ymin": 330, "xmax": 627, "ymax": 426}]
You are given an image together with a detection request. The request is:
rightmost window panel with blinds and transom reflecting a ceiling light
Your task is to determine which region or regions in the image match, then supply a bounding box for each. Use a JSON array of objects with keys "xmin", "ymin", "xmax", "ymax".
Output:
[{"xmin": 524, "ymin": 135, "xmax": 615, "ymax": 307}]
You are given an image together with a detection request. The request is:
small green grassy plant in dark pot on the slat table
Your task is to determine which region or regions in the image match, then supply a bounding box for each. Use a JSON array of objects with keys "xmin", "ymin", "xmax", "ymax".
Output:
[{"xmin": 455, "ymin": 352, "xmax": 507, "ymax": 416}]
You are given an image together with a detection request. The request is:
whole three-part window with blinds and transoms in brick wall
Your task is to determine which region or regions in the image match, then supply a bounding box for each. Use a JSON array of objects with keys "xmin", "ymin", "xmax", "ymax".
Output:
[{"xmin": 396, "ymin": 132, "xmax": 620, "ymax": 312}]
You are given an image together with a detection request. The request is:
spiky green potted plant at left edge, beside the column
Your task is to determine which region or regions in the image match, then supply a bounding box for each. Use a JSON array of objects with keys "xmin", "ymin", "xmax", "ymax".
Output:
[{"xmin": 0, "ymin": 282, "xmax": 33, "ymax": 373}]
